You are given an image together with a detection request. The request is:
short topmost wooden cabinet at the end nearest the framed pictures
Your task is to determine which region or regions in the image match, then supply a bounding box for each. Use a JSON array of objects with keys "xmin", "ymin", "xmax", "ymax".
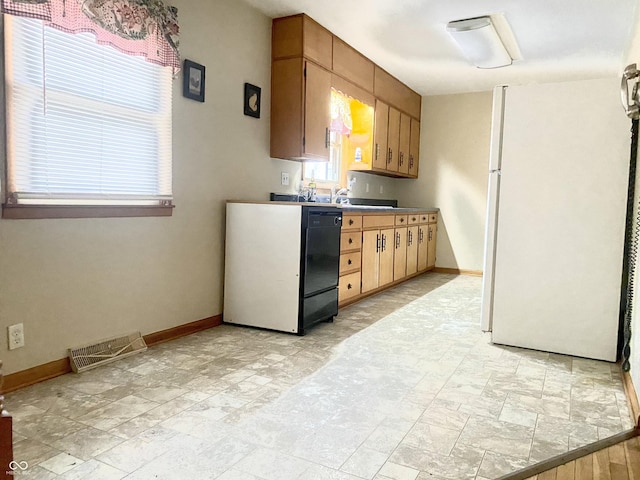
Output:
[{"xmin": 271, "ymin": 14, "xmax": 333, "ymax": 70}]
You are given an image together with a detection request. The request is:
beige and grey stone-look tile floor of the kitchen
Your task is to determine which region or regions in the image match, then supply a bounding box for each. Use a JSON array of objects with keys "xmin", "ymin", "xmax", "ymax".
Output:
[{"xmin": 7, "ymin": 273, "xmax": 632, "ymax": 480}]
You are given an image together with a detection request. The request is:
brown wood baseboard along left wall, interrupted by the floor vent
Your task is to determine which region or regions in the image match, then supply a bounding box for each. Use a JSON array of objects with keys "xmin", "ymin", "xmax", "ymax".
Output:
[{"xmin": 0, "ymin": 314, "xmax": 222, "ymax": 393}]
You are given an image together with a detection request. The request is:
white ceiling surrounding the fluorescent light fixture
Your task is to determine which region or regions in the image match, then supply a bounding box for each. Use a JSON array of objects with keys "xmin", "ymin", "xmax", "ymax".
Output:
[{"xmin": 245, "ymin": 0, "xmax": 638, "ymax": 95}]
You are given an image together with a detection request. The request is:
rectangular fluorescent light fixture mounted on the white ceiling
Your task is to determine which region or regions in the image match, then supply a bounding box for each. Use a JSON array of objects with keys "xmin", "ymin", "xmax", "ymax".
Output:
[{"xmin": 447, "ymin": 16, "xmax": 512, "ymax": 68}]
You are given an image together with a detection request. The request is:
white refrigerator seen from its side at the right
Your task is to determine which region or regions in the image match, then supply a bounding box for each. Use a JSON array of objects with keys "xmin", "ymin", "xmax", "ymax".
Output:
[{"xmin": 482, "ymin": 78, "xmax": 631, "ymax": 361}]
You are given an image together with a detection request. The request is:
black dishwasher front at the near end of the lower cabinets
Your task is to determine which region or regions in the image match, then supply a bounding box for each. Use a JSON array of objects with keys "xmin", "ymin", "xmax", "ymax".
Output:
[{"xmin": 298, "ymin": 206, "xmax": 342, "ymax": 335}]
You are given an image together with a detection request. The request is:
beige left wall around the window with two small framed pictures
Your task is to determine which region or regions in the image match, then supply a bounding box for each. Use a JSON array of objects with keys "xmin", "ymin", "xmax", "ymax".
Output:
[{"xmin": 0, "ymin": 0, "xmax": 284, "ymax": 373}]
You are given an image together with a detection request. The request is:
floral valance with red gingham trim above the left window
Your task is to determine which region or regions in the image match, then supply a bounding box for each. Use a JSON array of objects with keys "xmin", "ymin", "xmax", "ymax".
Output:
[{"xmin": 0, "ymin": 0, "xmax": 180, "ymax": 73}]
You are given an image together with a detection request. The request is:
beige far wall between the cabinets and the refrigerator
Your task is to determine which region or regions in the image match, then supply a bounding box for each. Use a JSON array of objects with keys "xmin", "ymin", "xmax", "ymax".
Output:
[{"xmin": 397, "ymin": 92, "xmax": 492, "ymax": 271}]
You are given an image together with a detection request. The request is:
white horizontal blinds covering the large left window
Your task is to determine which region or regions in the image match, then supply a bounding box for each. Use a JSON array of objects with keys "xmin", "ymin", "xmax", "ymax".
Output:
[{"xmin": 5, "ymin": 16, "xmax": 172, "ymax": 205}]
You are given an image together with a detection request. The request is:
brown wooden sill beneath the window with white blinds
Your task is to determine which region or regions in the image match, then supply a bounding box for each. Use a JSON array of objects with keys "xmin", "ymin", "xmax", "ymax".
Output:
[{"xmin": 2, "ymin": 205, "xmax": 174, "ymax": 219}]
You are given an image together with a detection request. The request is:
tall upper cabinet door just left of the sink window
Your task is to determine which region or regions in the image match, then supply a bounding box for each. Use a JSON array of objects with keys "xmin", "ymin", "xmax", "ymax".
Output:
[{"xmin": 304, "ymin": 62, "xmax": 331, "ymax": 160}]
